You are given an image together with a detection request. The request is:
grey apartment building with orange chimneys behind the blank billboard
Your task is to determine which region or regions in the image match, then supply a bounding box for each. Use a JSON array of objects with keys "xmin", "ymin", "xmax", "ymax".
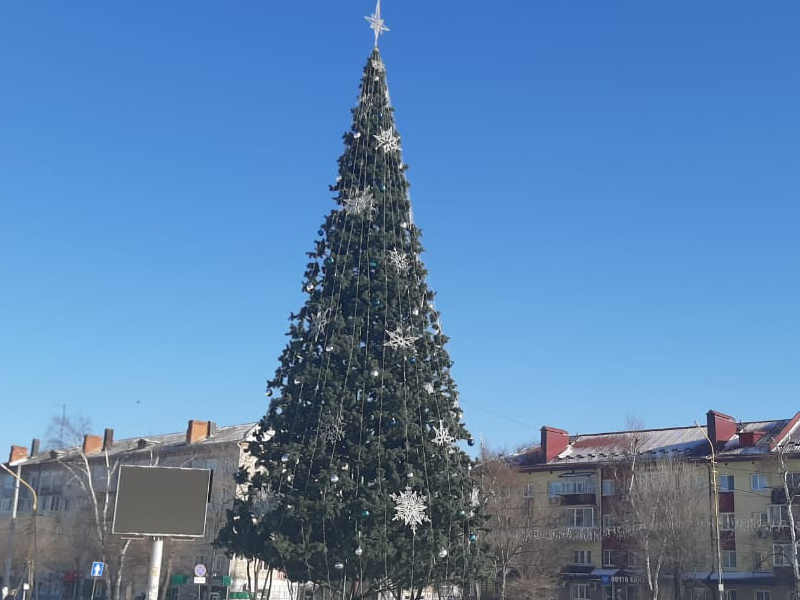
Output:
[{"xmin": 0, "ymin": 419, "xmax": 289, "ymax": 600}]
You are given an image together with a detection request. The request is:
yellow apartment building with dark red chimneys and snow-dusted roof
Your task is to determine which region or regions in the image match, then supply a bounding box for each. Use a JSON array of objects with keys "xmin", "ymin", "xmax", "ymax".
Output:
[{"xmin": 489, "ymin": 410, "xmax": 800, "ymax": 600}]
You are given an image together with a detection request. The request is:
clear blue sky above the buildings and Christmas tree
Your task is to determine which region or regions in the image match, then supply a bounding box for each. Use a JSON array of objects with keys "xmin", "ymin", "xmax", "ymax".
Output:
[{"xmin": 0, "ymin": 0, "xmax": 800, "ymax": 458}]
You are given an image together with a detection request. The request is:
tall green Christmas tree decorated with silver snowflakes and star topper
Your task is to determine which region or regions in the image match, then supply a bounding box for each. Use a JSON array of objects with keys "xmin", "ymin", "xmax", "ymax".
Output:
[{"xmin": 218, "ymin": 2, "xmax": 483, "ymax": 598}]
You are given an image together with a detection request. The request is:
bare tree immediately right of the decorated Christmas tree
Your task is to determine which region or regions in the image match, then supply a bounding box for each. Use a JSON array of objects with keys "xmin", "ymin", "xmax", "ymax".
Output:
[{"xmin": 479, "ymin": 447, "xmax": 564, "ymax": 600}]
